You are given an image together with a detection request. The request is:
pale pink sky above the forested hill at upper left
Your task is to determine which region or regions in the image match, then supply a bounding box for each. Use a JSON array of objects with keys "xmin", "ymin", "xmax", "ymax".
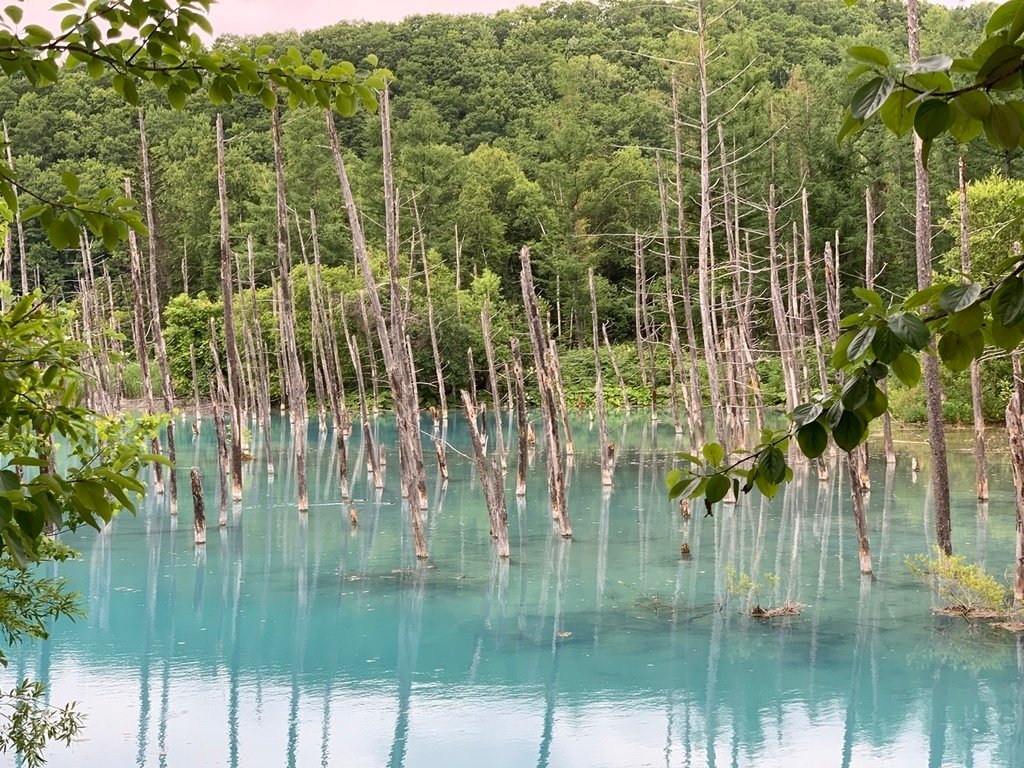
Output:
[{"xmin": 23, "ymin": 0, "xmax": 541, "ymax": 35}]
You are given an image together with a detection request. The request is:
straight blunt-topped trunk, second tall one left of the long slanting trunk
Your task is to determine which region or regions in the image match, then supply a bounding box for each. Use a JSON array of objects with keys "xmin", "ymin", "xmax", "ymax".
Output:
[{"xmin": 217, "ymin": 114, "xmax": 242, "ymax": 502}]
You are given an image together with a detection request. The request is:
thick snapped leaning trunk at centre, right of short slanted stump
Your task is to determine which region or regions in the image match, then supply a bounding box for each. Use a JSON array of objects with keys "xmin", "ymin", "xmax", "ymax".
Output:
[{"xmin": 519, "ymin": 248, "xmax": 572, "ymax": 539}]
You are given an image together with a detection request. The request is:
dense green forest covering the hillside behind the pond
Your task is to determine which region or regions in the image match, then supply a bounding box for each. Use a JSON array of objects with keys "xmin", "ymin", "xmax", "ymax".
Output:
[{"xmin": 6, "ymin": 0, "xmax": 1019, "ymax": 420}]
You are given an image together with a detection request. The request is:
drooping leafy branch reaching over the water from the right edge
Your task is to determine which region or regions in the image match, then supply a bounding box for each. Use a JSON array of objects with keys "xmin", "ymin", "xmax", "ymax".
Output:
[{"xmin": 666, "ymin": 268, "xmax": 1024, "ymax": 507}]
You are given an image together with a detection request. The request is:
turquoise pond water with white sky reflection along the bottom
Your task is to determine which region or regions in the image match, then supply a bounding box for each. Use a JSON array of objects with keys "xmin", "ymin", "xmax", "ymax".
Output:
[{"xmin": 6, "ymin": 415, "xmax": 1024, "ymax": 768}]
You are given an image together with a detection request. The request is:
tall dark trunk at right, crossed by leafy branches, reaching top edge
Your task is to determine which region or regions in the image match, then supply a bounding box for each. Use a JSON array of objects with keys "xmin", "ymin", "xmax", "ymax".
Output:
[{"xmin": 906, "ymin": 0, "xmax": 953, "ymax": 555}]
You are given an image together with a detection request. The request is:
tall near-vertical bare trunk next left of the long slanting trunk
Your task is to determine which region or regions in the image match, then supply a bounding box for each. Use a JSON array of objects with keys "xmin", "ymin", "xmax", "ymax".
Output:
[{"xmin": 270, "ymin": 102, "xmax": 309, "ymax": 512}]
